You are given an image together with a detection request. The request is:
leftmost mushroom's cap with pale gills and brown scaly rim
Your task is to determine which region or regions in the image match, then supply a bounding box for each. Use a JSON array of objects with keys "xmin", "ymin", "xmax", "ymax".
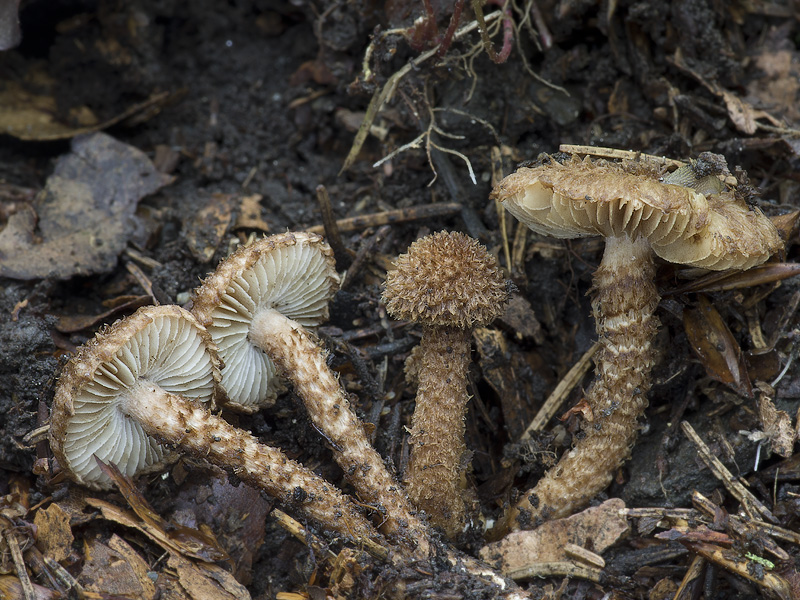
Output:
[{"xmin": 50, "ymin": 306, "xmax": 221, "ymax": 489}]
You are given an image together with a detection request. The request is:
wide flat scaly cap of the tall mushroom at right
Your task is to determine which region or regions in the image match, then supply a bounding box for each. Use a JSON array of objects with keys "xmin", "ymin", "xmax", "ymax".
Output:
[{"xmin": 492, "ymin": 158, "xmax": 783, "ymax": 271}]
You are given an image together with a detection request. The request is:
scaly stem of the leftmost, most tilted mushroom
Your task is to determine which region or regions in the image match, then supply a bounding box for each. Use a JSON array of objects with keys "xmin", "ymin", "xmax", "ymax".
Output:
[{"xmin": 121, "ymin": 381, "xmax": 379, "ymax": 546}]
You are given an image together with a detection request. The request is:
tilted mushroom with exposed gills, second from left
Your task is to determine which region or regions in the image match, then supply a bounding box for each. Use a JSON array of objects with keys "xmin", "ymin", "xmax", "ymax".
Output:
[{"xmin": 192, "ymin": 233, "xmax": 427, "ymax": 552}]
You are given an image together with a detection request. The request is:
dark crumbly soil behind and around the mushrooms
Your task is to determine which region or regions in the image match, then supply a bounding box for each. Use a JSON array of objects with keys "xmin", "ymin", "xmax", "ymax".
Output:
[{"xmin": 0, "ymin": 0, "xmax": 800, "ymax": 598}]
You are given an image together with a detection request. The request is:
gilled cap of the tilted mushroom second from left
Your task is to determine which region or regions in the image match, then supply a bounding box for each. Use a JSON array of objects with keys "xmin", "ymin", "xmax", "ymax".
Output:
[{"xmin": 192, "ymin": 233, "xmax": 339, "ymax": 412}]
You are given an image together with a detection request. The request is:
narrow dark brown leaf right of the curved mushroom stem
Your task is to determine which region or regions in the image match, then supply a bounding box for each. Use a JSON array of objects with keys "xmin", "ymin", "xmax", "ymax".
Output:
[{"xmin": 683, "ymin": 296, "xmax": 753, "ymax": 398}]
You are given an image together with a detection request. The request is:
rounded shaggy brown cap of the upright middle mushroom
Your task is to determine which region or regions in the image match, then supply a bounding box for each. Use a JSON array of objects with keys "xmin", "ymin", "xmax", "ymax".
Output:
[{"xmin": 383, "ymin": 231, "xmax": 508, "ymax": 328}]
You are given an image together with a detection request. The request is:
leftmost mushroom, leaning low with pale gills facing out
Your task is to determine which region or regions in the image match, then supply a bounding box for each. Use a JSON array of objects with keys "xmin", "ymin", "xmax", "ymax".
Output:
[{"xmin": 50, "ymin": 306, "xmax": 377, "ymax": 543}]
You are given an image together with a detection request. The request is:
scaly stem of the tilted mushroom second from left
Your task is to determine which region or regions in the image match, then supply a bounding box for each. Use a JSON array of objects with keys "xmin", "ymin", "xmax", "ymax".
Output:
[{"xmin": 249, "ymin": 308, "xmax": 429, "ymax": 556}]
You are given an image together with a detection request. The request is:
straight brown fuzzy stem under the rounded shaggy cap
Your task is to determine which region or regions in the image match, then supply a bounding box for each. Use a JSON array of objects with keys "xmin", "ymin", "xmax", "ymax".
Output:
[{"xmin": 405, "ymin": 326, "xmax": 471, "ymax": 537}]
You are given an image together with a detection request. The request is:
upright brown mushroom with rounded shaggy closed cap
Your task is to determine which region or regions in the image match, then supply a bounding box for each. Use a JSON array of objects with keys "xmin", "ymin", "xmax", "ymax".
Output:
[{"xmin": 383, "ymin": 231, "xmax": 508, "ymax": 538}]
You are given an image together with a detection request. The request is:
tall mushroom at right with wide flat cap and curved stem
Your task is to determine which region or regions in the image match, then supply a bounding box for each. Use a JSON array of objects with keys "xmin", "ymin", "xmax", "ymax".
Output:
[{"xmin": 492, "ymin": 157, "xmax": 783, "ymax": 535}]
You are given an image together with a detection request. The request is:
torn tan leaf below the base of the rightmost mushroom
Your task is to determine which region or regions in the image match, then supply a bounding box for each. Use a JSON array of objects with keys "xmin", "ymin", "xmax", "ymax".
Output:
[{"xmin": 480, "ymin": 498, "xmax": 630, "ymax": 578}]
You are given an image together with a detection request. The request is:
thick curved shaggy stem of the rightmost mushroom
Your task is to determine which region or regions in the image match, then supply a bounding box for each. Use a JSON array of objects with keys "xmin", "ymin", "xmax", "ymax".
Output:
[{"xmin": 498, "ymin": 234, "xmax": 660, "ymax": 534}]
